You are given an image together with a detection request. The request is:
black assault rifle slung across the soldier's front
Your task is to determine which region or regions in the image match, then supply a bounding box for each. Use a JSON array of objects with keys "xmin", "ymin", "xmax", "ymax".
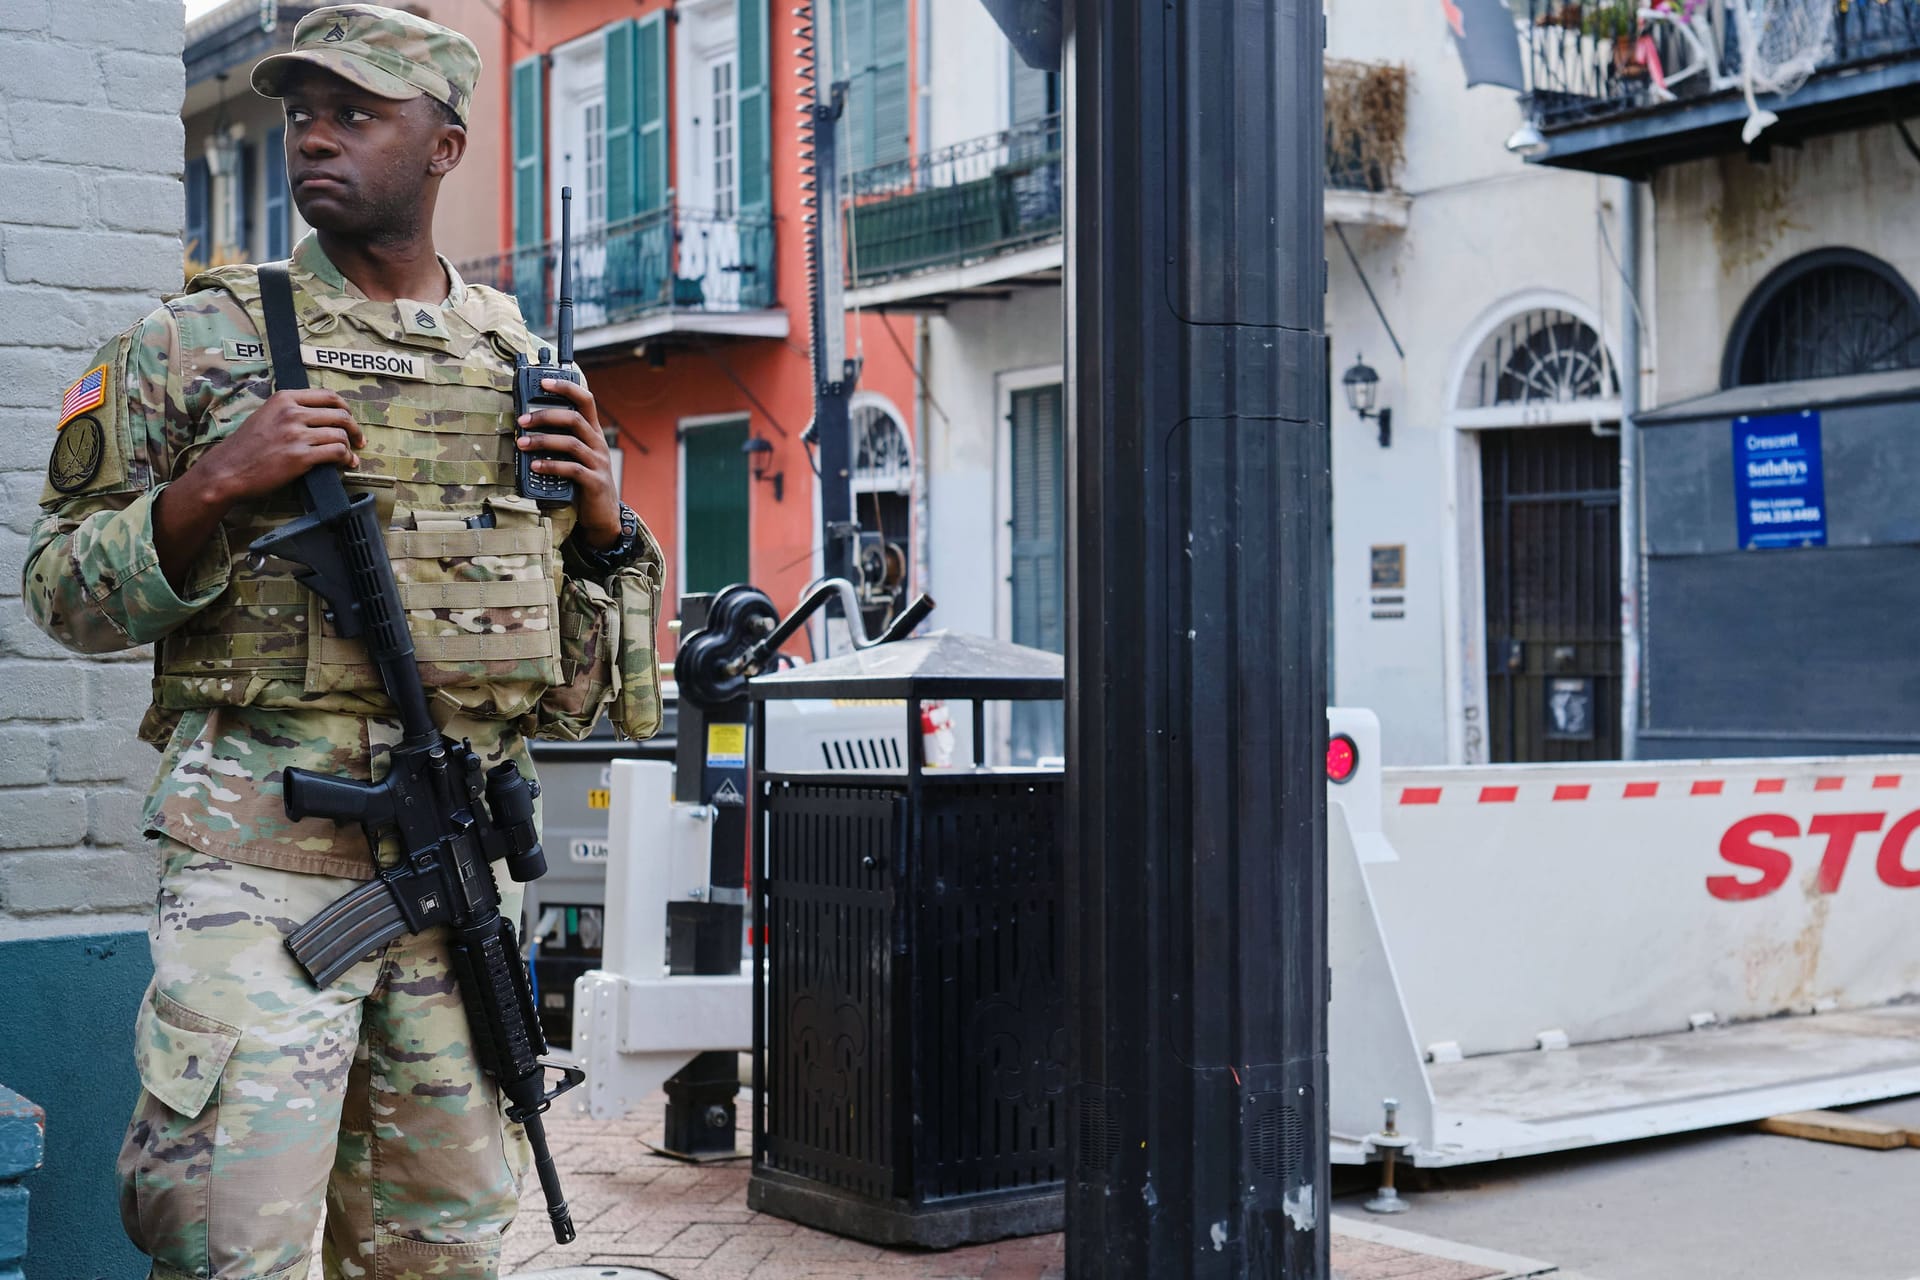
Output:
[{"xmin": 250, "ymin": 267, "xmax": 586, "ymax": 1244}]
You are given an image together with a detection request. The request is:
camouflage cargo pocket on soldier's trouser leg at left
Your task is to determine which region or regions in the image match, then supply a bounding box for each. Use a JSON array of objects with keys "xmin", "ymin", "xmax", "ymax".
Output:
[{"xmin": 119, "ymin": 986, "xmax": 240, "ymax": 1274}]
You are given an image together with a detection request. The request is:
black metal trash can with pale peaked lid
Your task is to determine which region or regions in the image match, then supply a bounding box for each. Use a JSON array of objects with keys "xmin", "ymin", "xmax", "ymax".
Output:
[{"xmin": 747, "ymin": 633, "xmax": 1068, "ymax": 1247}]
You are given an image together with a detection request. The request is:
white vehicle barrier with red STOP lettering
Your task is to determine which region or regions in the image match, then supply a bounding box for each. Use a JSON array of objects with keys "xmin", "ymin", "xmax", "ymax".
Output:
[{"xmin": 1329, "ymin": 710, "xmax": 1920, "ymax": 1165}]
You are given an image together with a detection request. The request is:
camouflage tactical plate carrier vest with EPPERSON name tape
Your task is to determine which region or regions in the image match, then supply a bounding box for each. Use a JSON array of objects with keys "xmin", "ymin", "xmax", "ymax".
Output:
[{"xmin": 156, "ymin": 267, "xmax": 576, "ymax": 720}]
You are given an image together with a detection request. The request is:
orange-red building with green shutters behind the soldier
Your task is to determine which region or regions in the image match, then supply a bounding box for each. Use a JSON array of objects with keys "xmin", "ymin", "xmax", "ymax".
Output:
[{"xmin": 461, "ymin": 0, "xmax": 916, "ymax": 647}]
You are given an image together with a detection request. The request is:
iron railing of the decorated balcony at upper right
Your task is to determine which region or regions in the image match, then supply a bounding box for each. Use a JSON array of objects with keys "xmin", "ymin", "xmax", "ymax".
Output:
[{"xmin": 1524, "ymin": 0, "xmax": 1920, "ymax": 129}]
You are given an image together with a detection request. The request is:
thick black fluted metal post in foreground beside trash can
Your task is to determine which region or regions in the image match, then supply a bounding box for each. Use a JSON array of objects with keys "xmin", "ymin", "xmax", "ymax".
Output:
[{"xmin": 1062, "ymin": 0, "xmax": 1331, "ymax": 1280}]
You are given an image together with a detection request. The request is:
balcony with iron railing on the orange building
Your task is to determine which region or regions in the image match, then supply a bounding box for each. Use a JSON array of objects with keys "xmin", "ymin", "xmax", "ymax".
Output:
[{"xmin": 461, "ymin": 209, "xmax": 787, "ymax": 353}]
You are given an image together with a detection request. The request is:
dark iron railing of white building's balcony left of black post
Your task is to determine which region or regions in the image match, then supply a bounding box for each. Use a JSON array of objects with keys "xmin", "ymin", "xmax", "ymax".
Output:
[{"xmin": 847, "ymin": 115, "xmax": 1066, "ymax": 288}]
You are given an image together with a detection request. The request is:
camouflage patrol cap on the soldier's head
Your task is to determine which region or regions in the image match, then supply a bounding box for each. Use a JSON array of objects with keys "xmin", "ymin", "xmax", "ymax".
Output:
[{"xmin": 253, "ymin": 4, "xmax": 480, "ymax": 121}]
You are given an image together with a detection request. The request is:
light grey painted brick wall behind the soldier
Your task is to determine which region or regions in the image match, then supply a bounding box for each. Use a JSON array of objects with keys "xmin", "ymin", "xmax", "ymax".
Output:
[{"xmin": 0, "ymin": 0, "xmax": 186, "ymax": 940}]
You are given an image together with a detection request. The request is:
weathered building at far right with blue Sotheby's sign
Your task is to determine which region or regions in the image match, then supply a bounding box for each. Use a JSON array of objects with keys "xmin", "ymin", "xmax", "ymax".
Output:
[{"xmin": 1512, "ymin": 0, "xmax": 1920, "ymax": 756}]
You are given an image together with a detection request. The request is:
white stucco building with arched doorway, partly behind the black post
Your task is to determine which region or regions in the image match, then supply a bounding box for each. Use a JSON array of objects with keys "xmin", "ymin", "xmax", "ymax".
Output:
[{"xmin": 849, "ymin": 0, "xmax": 1620, "ymax": 762}]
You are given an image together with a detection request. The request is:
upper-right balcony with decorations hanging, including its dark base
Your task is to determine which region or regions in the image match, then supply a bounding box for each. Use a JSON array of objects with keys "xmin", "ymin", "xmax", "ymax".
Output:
[{"xmin": 1523, "ymin": 0, "xmax": 1920, "ymax": 178}]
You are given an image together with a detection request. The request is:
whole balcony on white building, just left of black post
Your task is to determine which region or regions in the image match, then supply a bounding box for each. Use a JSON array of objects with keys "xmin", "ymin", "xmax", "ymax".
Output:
[{"xmin": 845, "ymin": 115, "xmax": 1066, "ymax": 307}]
